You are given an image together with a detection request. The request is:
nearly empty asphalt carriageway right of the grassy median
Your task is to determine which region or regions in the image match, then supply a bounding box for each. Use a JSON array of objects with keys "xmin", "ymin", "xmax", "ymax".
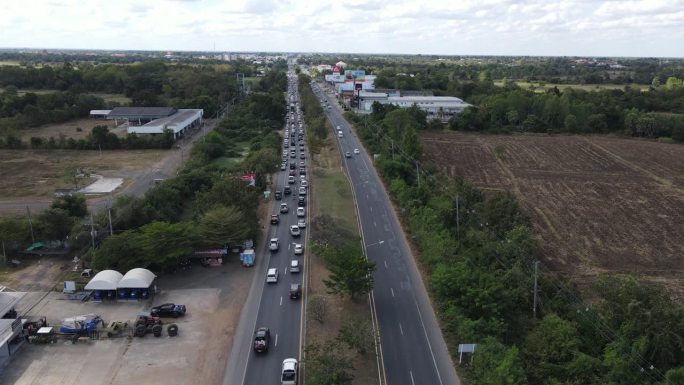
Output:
[{"xmin": 313, "ymin": 84, "xmax": 460, "ymax": 385}]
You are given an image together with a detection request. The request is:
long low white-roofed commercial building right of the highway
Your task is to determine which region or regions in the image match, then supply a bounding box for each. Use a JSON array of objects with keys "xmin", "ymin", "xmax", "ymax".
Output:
[{"xmin": 359, "ymin": 91, "xmax": 471, "ymax": 121}]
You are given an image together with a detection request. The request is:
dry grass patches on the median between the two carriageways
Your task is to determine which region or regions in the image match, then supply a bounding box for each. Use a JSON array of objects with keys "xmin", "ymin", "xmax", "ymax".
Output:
[{"xmin": 306, "ymin": 139, "xmax": 378, "ymax": 385}]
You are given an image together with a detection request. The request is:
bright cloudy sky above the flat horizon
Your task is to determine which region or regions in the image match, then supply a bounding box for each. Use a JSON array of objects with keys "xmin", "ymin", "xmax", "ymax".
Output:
[{"xmin": 0, "ymin": 0, "xmax": 684, "ymax": 57}]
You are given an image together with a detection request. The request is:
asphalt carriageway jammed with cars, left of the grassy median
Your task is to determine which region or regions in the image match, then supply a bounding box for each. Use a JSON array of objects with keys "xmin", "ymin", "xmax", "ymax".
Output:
[{"xmin": 224, "ymin": 67, "xmax": 309, "ymax": 385}]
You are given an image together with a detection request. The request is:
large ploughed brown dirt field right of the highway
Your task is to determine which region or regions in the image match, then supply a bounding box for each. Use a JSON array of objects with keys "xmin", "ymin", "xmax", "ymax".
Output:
[{"xmin": 421, "ymin": 133, "xmax": 684, "ymax": 299}]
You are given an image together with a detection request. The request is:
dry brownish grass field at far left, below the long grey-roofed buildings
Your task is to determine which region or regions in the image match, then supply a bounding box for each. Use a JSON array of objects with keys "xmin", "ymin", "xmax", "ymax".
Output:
[{"xmin": 0, "ymin": 150, "xmax": 167, "ymax": 200}]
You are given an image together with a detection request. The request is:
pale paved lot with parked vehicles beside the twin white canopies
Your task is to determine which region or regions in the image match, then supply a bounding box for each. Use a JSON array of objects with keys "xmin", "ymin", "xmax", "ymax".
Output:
[{"xmin": 0, "ymin": 256, "xmax": 255, "ymax": 385}]
